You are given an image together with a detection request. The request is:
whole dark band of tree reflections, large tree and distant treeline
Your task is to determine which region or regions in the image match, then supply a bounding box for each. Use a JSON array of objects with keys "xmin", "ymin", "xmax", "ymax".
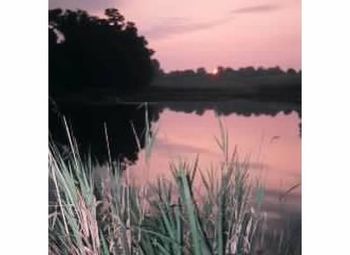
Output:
[{"xmin": 49, "ymin": 100, "xmax": 301, "ymax": 167}]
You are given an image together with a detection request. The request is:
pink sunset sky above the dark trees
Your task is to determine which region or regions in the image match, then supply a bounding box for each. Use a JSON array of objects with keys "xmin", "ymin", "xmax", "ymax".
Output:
[{"xmin": 49, "ymin": 0, "xmax": 301, "ymax": 71}]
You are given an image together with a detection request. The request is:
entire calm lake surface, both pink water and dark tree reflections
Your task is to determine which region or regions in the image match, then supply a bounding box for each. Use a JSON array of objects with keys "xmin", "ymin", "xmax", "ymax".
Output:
[{"xmin": 50, "ymin": 100, "xmax": 301, "ymax": 229}]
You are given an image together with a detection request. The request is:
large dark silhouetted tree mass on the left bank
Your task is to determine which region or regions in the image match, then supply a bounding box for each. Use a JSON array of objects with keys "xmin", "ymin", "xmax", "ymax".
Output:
[{"xmin": 49, "ymin": 9, "xmax": 154, "ymax": 95}]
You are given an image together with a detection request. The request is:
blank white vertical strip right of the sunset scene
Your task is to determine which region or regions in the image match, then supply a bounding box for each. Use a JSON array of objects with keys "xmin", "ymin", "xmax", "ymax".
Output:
[{"xmin": 302, "ymin": 0, "xmax": 350, "ymax": 254}]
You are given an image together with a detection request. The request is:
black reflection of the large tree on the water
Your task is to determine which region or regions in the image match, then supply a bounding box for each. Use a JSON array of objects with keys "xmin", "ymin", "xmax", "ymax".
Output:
[{"xmin": 49, "ymin": 101, "xmax": 150, "ymax": 163}]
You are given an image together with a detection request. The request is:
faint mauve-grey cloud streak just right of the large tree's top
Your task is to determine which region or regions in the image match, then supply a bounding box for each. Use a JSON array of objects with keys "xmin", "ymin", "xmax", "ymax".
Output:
[{"xmin": 144, "ymin": 16, "xmax": 232, "ymax": 39}]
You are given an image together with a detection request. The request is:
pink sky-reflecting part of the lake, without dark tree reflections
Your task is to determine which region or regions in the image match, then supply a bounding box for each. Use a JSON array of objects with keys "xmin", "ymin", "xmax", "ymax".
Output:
[{"xmin": 129, "ymin": 104, "xmax": 301, "ymax": 228}]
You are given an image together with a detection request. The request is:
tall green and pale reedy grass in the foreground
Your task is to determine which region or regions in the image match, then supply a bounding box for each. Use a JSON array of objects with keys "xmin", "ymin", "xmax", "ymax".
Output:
[{"xmin": 49, "ymin": 116, "xmax": 296, "ymax": 255}]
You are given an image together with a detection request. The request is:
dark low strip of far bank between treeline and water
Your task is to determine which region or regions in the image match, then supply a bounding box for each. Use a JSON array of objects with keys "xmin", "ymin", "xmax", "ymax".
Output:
[{"xmin": 55, "ymin": 86, "xmax": 301, "ymax": 105}]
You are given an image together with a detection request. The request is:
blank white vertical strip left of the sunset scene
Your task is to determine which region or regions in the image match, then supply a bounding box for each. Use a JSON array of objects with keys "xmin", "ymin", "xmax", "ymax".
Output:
[{"xmin": 0, "ymin": 1, "xmax": 48, "ymax": 254}]
